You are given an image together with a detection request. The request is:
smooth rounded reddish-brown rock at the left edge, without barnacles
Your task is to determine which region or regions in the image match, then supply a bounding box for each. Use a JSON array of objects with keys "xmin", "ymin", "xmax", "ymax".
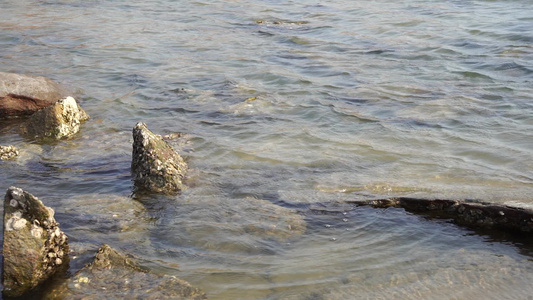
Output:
[{"xmin": 0, "ymin": 72, "xmax": 66, "ymax": 118}]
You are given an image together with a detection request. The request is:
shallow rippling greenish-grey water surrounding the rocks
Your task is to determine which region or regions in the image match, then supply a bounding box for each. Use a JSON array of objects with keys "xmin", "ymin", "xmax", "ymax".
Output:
[{"xmin": 0, "ymin": 0, "xmax": 533, "ymax": 299}]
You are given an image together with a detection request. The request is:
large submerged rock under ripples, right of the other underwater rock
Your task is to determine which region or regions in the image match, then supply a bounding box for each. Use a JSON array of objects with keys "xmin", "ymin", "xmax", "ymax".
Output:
[{"xmin": 181, "ymin": 195, "xmax": 307, "ymax": 255}]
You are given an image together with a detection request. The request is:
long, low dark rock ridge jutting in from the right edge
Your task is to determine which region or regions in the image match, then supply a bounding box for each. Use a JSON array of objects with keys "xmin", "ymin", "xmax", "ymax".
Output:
[{"xmin": 353, "ymin": 197, "xmax": 533, "ymax": 232}]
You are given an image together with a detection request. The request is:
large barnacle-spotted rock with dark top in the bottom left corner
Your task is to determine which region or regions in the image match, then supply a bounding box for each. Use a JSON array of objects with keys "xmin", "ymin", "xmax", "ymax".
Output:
[{"xmin": 3, "ymin": 187, "xmax": 69, "ymax": 297}]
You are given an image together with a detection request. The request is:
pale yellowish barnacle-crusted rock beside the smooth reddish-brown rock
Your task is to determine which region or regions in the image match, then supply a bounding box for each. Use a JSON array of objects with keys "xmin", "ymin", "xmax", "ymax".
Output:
[{"xmin": 23, "ymin": 97, "xmax": 89, "ymax": 139}]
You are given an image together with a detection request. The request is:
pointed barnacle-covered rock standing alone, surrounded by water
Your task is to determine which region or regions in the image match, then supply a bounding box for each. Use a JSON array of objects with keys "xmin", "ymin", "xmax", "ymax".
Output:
[{"xmin": 131, "ymin": 123, "xmax": 187, "ymax": 194}]
